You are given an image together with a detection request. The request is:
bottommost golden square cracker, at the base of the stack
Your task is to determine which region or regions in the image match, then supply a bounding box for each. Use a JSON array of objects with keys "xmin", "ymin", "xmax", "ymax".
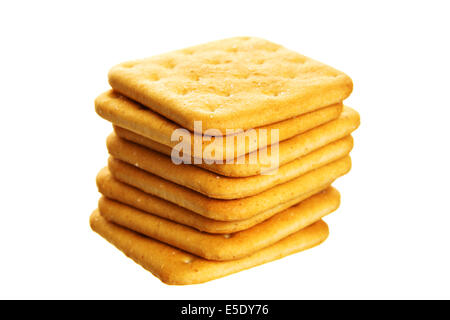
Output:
[{"xmin": 90, "ymin": 210, "xmax": 329, "ymax": 285}]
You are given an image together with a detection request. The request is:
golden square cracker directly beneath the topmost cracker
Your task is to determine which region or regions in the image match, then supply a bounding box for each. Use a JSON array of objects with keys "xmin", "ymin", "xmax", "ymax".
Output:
[{"xmin": 95, "ymin": 90, "xmax": 343, "ymax": 160}]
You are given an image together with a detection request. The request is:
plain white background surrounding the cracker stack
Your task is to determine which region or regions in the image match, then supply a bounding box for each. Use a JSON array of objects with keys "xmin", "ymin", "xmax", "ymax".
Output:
[{"xmin": 0, "ymin": 0, "xmax": 450, "ymax": 299}]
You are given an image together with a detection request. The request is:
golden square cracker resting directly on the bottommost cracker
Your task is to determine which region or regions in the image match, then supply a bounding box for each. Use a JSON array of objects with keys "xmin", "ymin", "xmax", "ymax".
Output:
[{"xmin": 98, "ymin": 188, "xmax": 340, "ymax": 261}]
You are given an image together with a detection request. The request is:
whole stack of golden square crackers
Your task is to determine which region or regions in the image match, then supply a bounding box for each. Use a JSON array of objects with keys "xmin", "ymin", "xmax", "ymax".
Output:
[{"xmin": 90, "ymin": 37, "xmax": 359, "ymax": 284}]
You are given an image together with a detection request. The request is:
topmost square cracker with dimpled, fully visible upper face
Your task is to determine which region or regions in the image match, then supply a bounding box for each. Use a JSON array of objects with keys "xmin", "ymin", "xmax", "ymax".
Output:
[{"xmin": 108, "ymin": 37, "xmax": 353, "ymax": 134}]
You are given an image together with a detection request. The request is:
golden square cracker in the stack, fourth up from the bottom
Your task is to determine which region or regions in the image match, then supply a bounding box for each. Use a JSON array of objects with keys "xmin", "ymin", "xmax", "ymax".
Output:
[{"xmin": 108, "ymin": 156, "xmax": 351, "ymax": 221}]
